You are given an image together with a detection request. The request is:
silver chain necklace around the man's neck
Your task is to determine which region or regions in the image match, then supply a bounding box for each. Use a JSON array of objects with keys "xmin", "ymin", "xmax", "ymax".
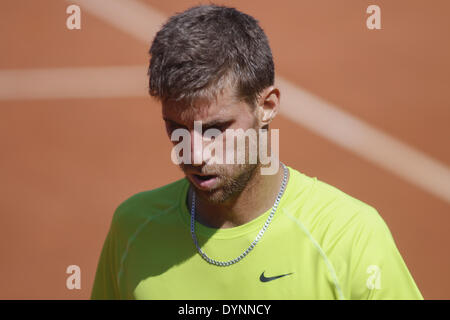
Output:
[{"xmin": 191, "ymin": 163, "xmax": 288, "ymax": 267}]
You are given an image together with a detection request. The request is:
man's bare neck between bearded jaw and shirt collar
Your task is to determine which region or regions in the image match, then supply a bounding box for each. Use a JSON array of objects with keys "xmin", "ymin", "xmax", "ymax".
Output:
[{"xmin": 187, "ymin": 164, "xmax": 284, "ymax": 228}]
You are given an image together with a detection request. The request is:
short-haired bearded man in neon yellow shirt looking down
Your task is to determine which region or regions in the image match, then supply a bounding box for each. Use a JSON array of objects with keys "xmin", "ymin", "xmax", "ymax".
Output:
[{"xmin": 91, "ymin": 5, "xmax": 423, "ymax": 299}]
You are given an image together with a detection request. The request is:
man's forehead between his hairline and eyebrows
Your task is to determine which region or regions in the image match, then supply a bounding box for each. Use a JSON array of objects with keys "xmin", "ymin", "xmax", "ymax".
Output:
[{"xmin": 162, "ymin": 87, "xmax": 250, "ymax": 125}]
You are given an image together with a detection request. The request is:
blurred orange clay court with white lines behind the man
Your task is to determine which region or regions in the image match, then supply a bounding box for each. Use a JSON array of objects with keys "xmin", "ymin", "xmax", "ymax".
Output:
[{"xmin": 0, "ymin": 0, "xmax": 450, "ymax": 299}]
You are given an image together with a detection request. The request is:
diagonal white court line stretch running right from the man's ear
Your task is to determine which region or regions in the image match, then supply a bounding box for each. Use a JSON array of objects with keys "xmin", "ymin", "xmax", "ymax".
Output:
[{"xmin": 276, "ymin": 77, "xmax": 450, "ymax": 202}]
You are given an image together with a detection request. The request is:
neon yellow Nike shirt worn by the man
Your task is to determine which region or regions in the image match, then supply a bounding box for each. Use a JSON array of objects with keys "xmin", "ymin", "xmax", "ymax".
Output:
[{"xmin": 91, "ymin": 168, "xmax": 423, "ymax": 300}]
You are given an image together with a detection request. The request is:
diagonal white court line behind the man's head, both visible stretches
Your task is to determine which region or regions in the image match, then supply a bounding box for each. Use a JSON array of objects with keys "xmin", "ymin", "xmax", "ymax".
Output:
[{"xmin": 70, "ymin": 0, "xmax": 450, "ymax": 202}]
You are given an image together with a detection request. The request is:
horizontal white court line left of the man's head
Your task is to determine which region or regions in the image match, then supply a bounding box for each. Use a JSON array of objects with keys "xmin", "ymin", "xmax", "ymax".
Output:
[{"xmin": 0, "ymin": 66, "xmax": 148, "ymax": 100}]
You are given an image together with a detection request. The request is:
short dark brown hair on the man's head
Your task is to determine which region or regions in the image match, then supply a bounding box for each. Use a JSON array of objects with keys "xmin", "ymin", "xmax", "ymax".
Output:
[{"xmin": 148, "ymin": 4, "xmax": 274, "ymax": 106}]
